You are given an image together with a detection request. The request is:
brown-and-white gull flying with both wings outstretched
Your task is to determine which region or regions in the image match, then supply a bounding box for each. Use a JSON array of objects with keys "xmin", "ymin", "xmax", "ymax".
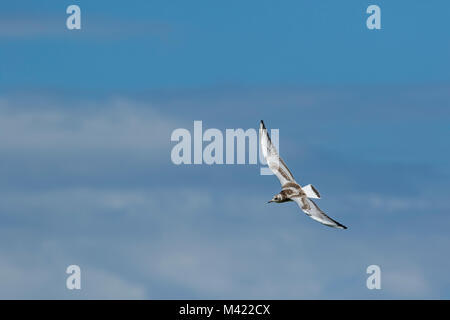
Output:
[{"xmin": 259, "ymin": 120, "xmax": 347, "ymax": 229}]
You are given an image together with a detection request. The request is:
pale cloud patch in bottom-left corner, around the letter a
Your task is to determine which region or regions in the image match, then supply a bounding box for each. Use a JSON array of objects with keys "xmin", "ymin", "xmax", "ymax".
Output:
[{"xmin": 0, "ymin": 252, "xmax": 147, "ymax": 299}]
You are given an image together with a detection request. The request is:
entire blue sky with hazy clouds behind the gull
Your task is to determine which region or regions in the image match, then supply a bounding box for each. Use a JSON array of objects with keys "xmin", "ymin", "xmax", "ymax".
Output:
[{"xmin": 0, "ymin": 1, "xmax": 450, "ymax": 299}]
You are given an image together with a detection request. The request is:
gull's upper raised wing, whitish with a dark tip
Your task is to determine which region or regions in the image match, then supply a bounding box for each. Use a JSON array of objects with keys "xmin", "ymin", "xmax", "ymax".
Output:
[{"xmin": 259, "ymin": 120, "xmax": 295, "ymax": 186}]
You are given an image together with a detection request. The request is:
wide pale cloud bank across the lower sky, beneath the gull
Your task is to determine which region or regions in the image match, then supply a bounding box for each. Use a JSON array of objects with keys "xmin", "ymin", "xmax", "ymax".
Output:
[{"xmin": 0, "ymin": 182, "xmax": 446, "ymax": 299}]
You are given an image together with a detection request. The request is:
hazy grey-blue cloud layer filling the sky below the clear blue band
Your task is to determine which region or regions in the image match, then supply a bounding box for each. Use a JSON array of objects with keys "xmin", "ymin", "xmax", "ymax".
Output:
[{"xmin": 0, "ymin": 88, "xmax": 450, "ymax": 299}]
